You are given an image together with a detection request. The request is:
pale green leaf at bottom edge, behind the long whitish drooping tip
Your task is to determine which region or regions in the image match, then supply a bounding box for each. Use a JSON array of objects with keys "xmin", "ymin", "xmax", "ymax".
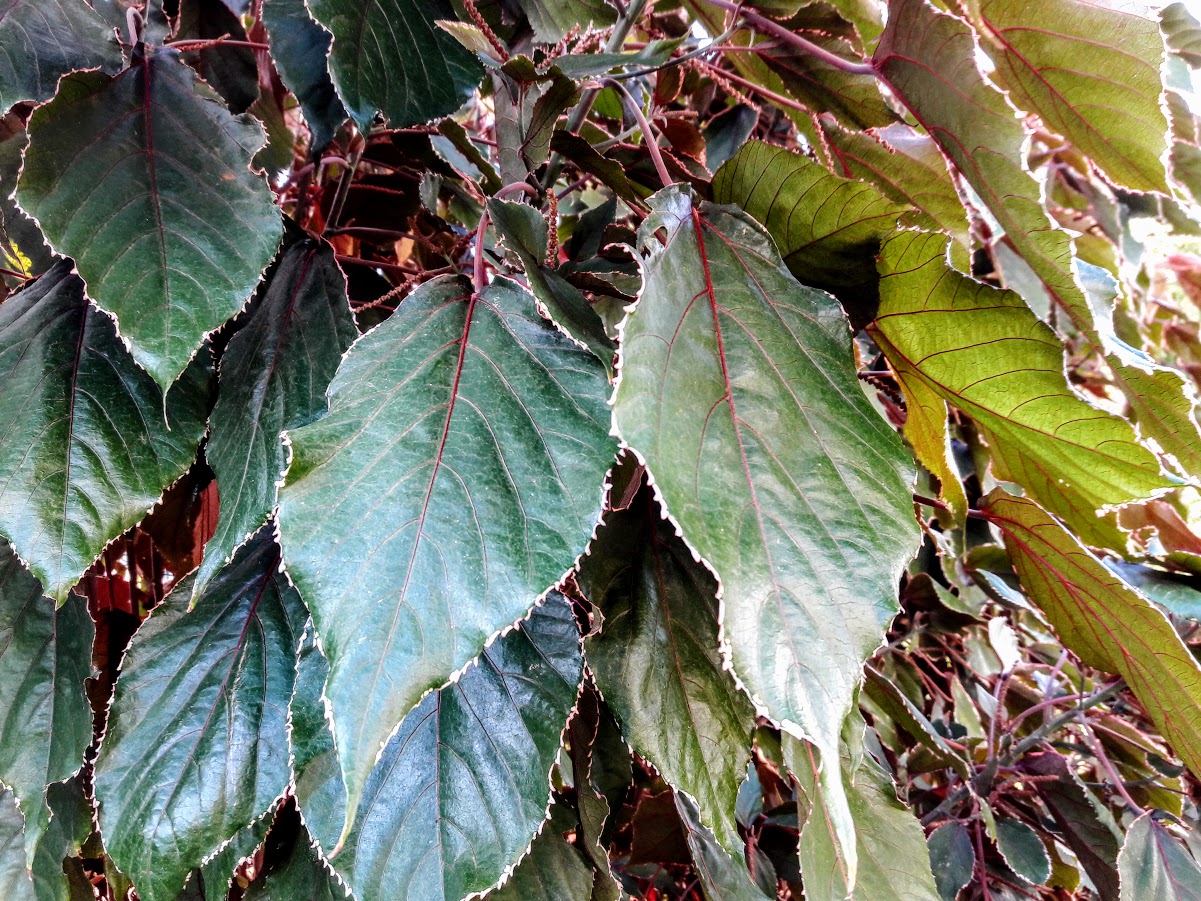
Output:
[{"xmin": 784, "ymin": 736, "xmax": 939, "ymax": 901}]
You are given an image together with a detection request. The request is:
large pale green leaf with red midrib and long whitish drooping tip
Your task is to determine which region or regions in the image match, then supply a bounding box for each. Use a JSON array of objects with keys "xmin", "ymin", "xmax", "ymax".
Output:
[{"xmin": 614, "ymin": 187, "xmax": 916, "ymax": 884}]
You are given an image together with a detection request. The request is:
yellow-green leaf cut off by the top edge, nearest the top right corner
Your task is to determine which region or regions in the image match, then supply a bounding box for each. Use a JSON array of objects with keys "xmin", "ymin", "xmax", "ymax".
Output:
[{"xmin": 969, "ymin": 0, "xmax": 1169, "ymax": 193}]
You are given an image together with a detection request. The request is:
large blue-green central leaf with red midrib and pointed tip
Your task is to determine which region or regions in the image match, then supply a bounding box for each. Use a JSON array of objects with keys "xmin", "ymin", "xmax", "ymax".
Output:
[{"xmin": 280, "ymin": 276, "xmax": 615, "ymax": 828}]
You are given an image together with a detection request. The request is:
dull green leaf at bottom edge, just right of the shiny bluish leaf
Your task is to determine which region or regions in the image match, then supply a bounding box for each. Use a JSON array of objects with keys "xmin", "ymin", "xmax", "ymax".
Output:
[{"xmin": 484, "ymin": 800, "xmax": 596, "ymax": 901}]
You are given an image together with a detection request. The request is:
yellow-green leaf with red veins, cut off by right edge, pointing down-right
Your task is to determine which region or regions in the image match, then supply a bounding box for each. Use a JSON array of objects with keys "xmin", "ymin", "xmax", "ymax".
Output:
[{"xmin": 981, "ymin": 488, "xmax": 1201, "ymax": 772}]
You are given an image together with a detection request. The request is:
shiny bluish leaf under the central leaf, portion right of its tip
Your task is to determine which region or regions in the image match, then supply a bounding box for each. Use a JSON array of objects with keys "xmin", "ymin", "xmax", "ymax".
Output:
[{"xmin": 333, "ymin": 600, "xmax": 584, "ymax": 901}]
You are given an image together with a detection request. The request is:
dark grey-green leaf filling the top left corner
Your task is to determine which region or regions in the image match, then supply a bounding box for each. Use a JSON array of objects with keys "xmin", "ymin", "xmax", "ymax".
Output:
[{"xmin": 0, "ymin": 0, "xmax": 121, "ymax": 113}]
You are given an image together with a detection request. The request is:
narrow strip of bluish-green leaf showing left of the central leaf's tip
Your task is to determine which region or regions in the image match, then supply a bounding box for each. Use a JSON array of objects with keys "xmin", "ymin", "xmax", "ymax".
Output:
[{"xmin": 289, "ymin": 623, "xmax": 346, "ymax": 853}]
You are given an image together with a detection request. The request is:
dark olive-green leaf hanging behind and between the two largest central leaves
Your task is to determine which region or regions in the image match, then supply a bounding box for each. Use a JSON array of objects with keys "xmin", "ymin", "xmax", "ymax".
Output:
[{"xmin": 576, "ymin": 488, "xmax": 754, "ymax": 854}]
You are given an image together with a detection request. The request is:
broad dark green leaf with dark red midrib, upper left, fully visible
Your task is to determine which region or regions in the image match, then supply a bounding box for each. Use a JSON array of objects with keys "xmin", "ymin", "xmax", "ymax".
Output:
[{"xmin": 17, "ymin": 48, "xmax": 282, "ymax": 390}]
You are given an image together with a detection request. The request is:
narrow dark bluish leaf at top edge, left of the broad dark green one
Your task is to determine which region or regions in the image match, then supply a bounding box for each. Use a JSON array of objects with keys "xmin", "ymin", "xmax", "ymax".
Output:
[{"xmin": 263, "ymin": 0, "xmax": 347, "ymax": 156}]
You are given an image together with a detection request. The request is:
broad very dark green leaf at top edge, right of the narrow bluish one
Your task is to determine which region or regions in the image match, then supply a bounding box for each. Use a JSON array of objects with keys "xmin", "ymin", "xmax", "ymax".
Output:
[{"xmin": 309, "ymin": 0, "xmax": 484, "ymax": 131}]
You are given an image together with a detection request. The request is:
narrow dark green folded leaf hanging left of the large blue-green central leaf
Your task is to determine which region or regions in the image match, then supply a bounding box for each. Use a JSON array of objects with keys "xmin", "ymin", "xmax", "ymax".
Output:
[{"xmin": 192, "ymin": 239, "xmax": 358, "ymax": 607}]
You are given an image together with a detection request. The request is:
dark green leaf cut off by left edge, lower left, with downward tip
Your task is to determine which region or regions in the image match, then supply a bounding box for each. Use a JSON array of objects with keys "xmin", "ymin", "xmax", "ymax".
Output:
[{"xmin": 0, "ymin": 538, "xmax": 95, "ymax": 864}]
